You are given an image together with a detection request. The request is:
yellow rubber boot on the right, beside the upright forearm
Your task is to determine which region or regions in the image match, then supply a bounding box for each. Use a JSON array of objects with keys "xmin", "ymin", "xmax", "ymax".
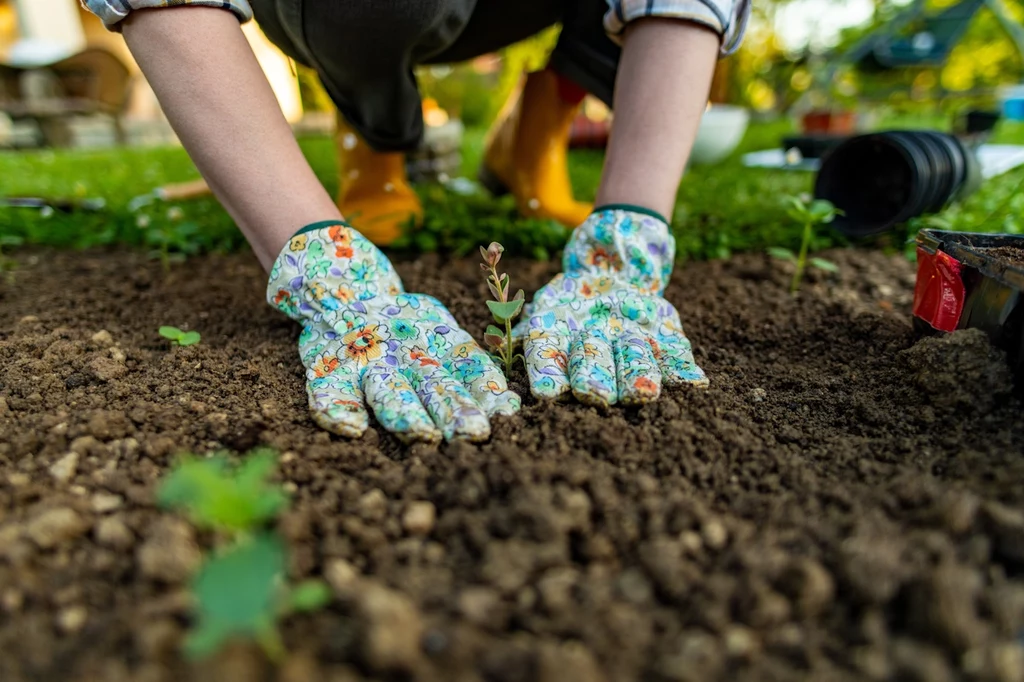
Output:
[{"xmin": 479, "ymin": 70, "xmax": 593, "ymax": 228}]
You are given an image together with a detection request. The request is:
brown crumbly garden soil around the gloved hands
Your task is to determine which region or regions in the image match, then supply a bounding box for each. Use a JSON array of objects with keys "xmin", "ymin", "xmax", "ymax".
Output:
[{"xmin": 0, "ymin": 251, "xmax": 1024, "ymax": 682}]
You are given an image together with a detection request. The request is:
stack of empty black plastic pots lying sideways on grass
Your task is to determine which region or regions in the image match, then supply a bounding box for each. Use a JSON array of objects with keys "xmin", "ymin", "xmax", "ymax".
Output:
[{"xmin": 814, "ymin": 130, "xmax": 981, "ymax": 238}]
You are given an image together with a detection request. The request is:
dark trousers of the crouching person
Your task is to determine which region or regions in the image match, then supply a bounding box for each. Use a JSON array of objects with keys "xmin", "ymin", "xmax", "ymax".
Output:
[{"xmin": 250, "ymin": 0, "xmax": 620, "ymax": 152}]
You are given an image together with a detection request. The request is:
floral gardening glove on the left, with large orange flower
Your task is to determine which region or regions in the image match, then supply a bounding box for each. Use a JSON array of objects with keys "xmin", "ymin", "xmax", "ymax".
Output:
[{"xmin": 266, "ymin": 222, "xmax": 520, "ymax": 442}]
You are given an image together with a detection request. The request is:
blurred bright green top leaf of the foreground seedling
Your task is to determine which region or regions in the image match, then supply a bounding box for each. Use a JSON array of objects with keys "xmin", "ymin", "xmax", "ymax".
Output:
[{"xmin": 157, "ymin": 451, "xmax": 288, "ymax": 532}]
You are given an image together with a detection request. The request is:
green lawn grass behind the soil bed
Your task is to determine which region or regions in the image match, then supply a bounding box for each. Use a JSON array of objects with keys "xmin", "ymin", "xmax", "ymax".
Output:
[{"xmin": 6, "ymin": 121, "xmax": 1024, "ymax": 259}]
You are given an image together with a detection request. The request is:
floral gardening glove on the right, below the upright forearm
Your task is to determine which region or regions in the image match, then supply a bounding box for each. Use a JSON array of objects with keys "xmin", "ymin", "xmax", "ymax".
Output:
[{"xmin": 514, "ymin": 207, "xmax": 708, "ymax": 406}]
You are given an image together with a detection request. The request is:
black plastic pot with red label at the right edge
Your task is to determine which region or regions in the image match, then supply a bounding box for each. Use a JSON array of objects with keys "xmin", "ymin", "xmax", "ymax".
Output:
[{"xmin": 913, "ymin": 229, "xmax": 1024, "ymax": 388}]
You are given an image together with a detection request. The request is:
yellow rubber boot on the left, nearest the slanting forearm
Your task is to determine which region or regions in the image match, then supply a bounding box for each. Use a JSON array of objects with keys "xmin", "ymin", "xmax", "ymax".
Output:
[{"xmin": 336, "ymin": 116, "xmax": 423, "ymax": 246}]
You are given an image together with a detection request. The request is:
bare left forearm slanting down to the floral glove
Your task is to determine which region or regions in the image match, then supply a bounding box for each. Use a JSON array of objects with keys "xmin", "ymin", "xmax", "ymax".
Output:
[{"xmin": 124, "ymin": 7, "xmax": 341, "ymax": 267}]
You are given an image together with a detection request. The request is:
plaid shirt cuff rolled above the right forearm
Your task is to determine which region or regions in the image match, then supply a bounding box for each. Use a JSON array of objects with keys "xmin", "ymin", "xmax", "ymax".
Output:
[{"xmin": 604, "ymin": 0, "xmax": 751, "ymax": 55}]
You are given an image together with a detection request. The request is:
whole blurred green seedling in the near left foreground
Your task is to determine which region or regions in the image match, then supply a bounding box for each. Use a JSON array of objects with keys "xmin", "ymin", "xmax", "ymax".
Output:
[{"xmin": 157, "ymin": 450, "xmax": 331, "ymax": 660}]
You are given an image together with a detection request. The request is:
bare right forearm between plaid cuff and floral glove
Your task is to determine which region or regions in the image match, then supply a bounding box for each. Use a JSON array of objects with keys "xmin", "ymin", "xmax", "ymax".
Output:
[{"xmin": 596, "ymin": 18, "xmax": 719, "ymax": 219}]
